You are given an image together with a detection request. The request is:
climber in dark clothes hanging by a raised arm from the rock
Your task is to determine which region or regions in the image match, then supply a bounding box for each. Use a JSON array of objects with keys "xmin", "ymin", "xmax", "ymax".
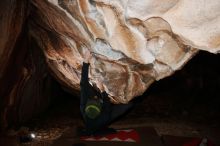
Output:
[{"xmin": 80, "ymin": 51, "xmax": 133, "ymax": 135}]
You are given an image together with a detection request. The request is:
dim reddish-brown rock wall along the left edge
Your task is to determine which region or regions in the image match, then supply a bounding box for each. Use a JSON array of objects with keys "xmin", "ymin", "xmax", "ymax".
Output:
[{"xmin": 0, "ymin": 0, "xmax": 27, "ymax": 128}]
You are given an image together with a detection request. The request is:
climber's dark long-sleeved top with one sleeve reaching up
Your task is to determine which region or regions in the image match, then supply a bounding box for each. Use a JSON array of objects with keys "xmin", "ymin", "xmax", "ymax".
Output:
[{"xmin": 80, "ymin": 63, "xmax": 112, "ymax": 134}]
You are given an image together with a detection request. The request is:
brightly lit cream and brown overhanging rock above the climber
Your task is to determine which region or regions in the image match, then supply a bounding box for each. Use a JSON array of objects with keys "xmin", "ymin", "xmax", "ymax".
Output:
[{"xmin": 30, "ymin": 0, "xmax": 220, "ymax": 103}]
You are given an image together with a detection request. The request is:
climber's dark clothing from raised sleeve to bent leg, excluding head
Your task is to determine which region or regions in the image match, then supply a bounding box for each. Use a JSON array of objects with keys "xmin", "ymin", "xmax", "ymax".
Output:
[{"xmin": 80, "ymin": 63, "xmax": 133, "ymax": 134}]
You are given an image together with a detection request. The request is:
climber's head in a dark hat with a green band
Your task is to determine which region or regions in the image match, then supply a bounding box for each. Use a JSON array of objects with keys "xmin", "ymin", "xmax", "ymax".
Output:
[{"xmin": 85, "ymin": 97, "xmax": 101, "ymax": 119}]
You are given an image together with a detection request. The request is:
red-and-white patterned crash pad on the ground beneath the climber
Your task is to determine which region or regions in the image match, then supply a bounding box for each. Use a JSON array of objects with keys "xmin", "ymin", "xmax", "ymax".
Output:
[{"xmin": 52, "ymin": 127, "xmax": 162, "ymax": 146}]
